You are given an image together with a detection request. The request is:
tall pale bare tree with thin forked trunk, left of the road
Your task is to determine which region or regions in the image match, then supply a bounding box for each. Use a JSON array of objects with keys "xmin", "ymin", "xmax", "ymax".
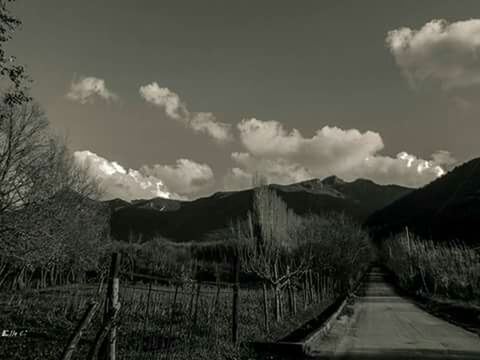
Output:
[{"xmin": 231, "ymin": 179, "xmax": 311, "ymax": 321}]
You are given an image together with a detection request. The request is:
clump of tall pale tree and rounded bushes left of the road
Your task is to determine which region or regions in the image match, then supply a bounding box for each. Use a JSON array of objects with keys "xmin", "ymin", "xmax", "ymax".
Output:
[{"xmin": 231, "ymin": 186, "xmax": 372, "ymax": 330}]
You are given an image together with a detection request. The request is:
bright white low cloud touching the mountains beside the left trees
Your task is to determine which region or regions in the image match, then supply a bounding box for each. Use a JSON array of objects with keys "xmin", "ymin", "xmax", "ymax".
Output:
[{"xmin": 74, "ymin": 151, "xmax": 213, "ymax": 201}]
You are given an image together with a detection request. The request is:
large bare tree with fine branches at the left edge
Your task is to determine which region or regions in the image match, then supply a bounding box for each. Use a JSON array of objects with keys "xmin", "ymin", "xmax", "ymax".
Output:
[{"xmin": 0, "ymin": 103, "xmax": 109, "ymax": 287}]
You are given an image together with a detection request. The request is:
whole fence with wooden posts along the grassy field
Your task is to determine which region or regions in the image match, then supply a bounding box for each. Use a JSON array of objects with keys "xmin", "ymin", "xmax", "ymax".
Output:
[{"xmin": 1, "ymin": 253, "xmax": 344, "ymax": 360}]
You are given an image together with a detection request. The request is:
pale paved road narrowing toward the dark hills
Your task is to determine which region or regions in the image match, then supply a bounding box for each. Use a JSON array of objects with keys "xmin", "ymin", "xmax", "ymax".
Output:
[{"xmin": 309, "ymin": 268, "xmax": 480, "ymax": 360}]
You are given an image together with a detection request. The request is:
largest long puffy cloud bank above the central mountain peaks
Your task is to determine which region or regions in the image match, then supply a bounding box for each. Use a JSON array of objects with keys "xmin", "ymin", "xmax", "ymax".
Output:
[{"xmin": 224, "ymin": 119, "xmax": 455, "ymax": 189}]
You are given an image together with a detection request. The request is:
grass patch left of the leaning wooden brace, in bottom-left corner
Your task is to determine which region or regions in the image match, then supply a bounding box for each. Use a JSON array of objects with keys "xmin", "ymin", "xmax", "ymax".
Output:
[{"xmin": 0, "ymin": 285, "xmax": 105, "ymax": 360}]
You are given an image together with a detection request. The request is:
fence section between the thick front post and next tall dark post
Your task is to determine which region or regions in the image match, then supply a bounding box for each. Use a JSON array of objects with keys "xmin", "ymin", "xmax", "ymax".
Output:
[{"xmin": 117, "ymin": 279, "xmax": 233, "ymax": 359}]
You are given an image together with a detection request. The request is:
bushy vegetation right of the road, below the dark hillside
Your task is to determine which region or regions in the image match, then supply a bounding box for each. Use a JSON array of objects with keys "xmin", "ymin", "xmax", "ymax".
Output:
[{"xmin": 382, "ymin": 230, "xmax": 480, "ymax": 302}]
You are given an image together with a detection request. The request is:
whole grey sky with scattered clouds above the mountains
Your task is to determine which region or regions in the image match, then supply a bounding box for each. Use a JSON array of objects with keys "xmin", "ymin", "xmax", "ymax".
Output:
[{"xmin": 8, "ymin": 0, "xmax": 480, "ymax": 200}]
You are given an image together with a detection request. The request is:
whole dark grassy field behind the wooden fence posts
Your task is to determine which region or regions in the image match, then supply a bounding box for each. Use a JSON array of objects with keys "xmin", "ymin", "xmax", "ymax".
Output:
[{"xmin": 0, "ymin": 278, "xmax": 333, "ymax": 360}]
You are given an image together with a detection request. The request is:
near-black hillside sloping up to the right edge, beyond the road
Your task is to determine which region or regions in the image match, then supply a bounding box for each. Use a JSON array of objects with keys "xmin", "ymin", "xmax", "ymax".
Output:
[{"xmin": 365, "ymin": 158, "xmax": 480, "ymax": 244}]
